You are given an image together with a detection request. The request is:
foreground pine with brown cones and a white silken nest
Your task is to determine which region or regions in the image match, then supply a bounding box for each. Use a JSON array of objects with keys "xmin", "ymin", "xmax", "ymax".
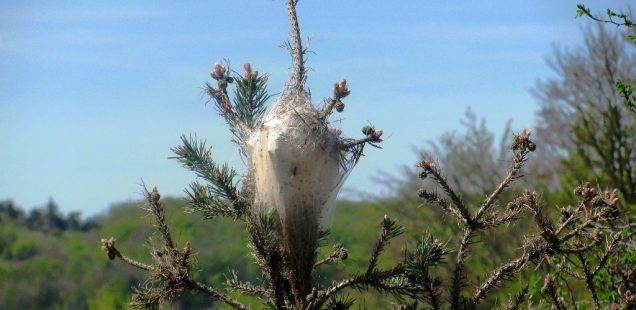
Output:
[{"xmin": 102, "ymin": 0, "xmax": 632, "ymax": 309}]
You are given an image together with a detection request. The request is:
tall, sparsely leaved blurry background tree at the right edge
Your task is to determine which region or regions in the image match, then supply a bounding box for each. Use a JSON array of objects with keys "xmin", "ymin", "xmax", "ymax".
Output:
[{"xmin": 532, "ymin": 25, "xmax": 636, "ymax": 204}]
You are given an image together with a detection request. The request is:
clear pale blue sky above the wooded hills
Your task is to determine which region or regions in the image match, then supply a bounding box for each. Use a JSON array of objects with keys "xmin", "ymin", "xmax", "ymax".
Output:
[{"xmin": 0, "ymin": 0, "xmax": 628, "ymax": 214}]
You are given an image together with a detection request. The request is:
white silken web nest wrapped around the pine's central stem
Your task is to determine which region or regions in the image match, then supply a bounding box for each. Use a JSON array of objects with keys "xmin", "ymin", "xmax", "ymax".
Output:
[{"xmin": 248, "ymin": 93, "xmax": 350, "ymax": 230}]
